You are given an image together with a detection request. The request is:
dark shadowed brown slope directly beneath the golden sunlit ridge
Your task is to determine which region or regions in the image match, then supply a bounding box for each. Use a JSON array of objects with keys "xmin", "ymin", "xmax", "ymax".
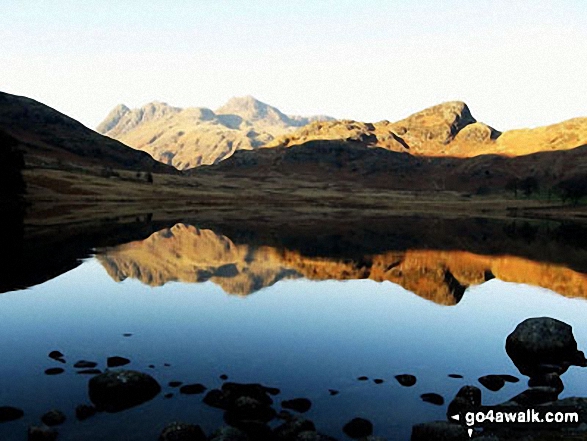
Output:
[{"xmin": 191, "ymin": 140, "xmax": 587, "ymax": 193}]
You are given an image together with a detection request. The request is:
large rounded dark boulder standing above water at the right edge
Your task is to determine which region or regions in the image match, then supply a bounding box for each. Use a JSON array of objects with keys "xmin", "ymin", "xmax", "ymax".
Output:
[{"xmin": 505, "ymin": 317, "xmax": 587, "ymax": 377}]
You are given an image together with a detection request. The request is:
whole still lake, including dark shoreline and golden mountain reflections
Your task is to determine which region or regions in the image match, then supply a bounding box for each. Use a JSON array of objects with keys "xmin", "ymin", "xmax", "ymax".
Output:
[{"xmin": 0, "ymin": 215, "xmax": 587, "ymax": 440}]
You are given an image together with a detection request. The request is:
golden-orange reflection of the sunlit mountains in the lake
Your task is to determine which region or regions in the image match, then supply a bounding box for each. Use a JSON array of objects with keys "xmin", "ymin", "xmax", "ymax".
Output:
[{"xmin": 96, "ymin": 223, "xmax": 587, "ymax": 305}]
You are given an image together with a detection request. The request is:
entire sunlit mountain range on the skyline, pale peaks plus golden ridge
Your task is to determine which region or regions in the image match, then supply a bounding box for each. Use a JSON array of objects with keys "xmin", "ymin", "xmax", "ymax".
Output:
[{"xmin": 97, "ymin": 96, "xmax": 587, "ymax": 170}]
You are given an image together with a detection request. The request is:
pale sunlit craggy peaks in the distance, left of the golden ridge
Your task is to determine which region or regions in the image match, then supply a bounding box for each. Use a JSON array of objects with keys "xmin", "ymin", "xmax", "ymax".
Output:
[{"xmin": 96, "ymin": 96, "xmax": 332, "ymax": 170}]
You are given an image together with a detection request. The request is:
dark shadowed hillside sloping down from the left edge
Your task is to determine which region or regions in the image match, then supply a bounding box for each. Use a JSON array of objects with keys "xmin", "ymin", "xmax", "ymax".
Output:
[{"xmin": 0, "ymin": 92, "xmax": 174, "ymax": 173}]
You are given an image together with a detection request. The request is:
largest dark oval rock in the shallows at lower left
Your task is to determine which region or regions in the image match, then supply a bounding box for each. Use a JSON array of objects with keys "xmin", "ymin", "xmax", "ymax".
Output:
[{"xmin": 88, "ymin": 370, "xmax": 161, "ymax": 412}]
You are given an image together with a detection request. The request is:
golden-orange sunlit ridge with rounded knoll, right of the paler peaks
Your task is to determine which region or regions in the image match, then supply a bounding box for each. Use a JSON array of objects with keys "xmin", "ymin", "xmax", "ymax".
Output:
[{"xmin": 270, "ymin": 101, "xmax": 587, "ymax": 158}]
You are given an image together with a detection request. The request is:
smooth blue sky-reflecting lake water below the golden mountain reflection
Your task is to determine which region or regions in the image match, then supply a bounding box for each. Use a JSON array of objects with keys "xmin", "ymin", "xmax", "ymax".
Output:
[{"xmin": 0, "ymin": 222, "xmax": 587, "ymax": 440}]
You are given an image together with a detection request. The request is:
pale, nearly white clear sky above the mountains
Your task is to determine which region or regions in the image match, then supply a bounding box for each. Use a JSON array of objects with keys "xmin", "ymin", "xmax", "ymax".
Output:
[{"xmin": 0, "ymin": 0, "xmax": 587, "ymax": 130}]
